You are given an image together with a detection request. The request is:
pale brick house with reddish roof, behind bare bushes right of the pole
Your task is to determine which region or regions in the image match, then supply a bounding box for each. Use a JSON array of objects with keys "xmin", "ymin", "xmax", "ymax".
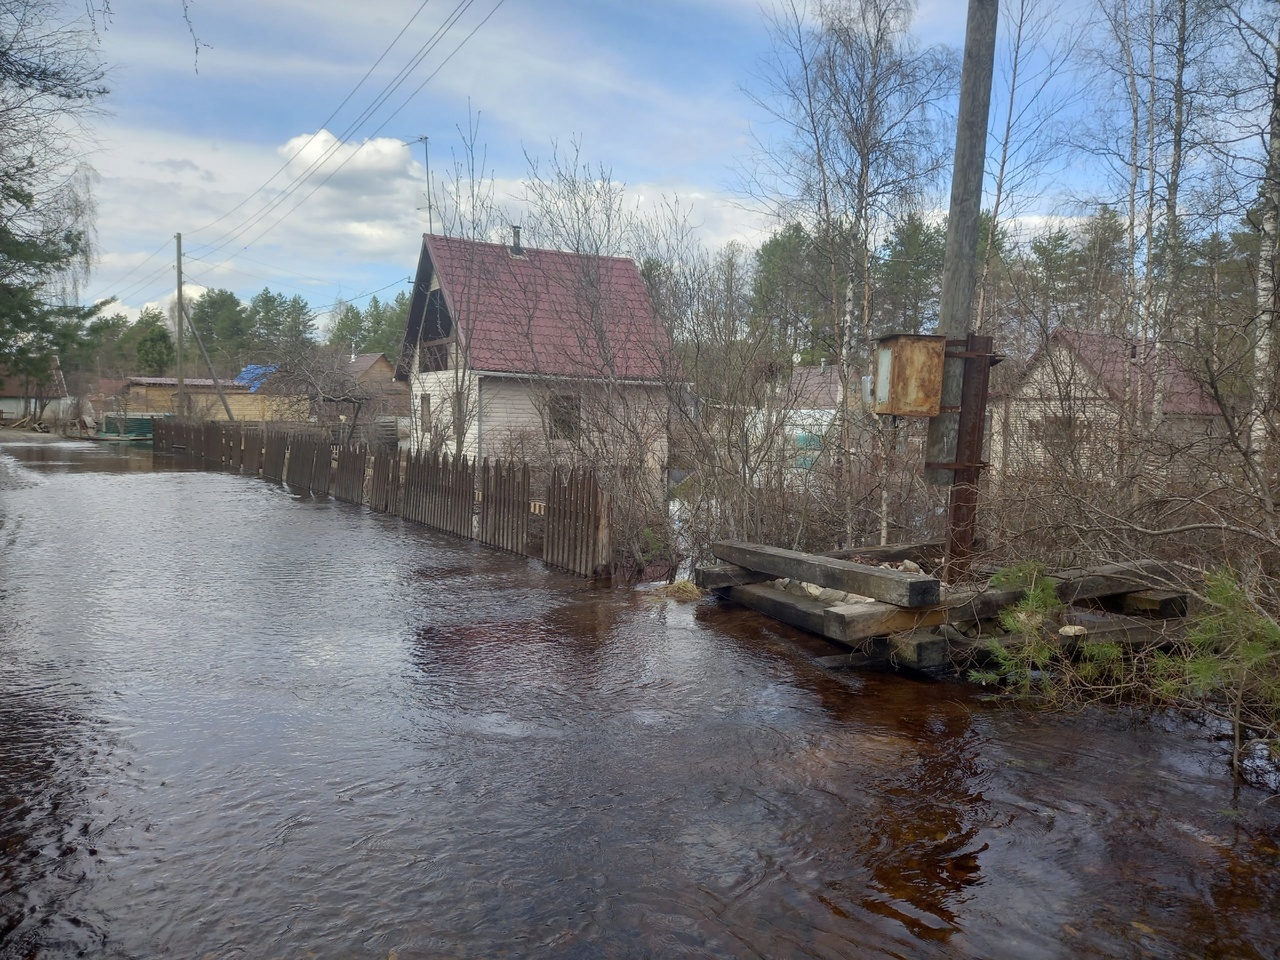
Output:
[{"xmin": 988, "ymin": 326, "xmax": 1226, "ymax": 480}]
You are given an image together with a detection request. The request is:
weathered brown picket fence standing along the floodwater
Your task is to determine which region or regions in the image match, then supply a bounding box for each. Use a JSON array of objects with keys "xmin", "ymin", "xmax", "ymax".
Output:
[{"xmin": 151, "ymin": 417, "xmax": 612, "ymax": 577}]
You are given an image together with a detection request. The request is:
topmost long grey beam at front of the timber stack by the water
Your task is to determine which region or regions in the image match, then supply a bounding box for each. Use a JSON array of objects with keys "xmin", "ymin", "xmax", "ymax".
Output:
[{"xmin": 712, "ymin": 540, "xmax": 941, "ymax": 607}]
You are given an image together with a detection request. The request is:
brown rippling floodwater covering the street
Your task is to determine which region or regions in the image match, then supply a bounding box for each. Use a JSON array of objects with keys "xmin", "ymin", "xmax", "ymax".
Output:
[{"xmin": 0, "ymin": 434, "xmax": 1280, "ymax": 960}]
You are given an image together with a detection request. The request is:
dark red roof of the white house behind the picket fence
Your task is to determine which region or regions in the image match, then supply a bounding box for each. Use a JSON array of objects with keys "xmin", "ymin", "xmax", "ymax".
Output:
[{"xmin": 410, "ymin": 234, "xmax": 672, "ymax": 380}]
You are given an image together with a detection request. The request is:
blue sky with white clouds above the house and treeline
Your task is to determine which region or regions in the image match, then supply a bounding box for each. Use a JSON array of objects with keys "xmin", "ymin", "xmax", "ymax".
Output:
[{"xmin": 87, "ymin": 0, "xmax": 965, "ymax": 327}]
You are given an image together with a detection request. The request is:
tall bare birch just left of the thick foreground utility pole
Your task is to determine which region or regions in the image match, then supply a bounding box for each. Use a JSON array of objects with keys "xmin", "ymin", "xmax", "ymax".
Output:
[{"xmin": 751, "ymin": 0, "xmax": 957, "ymax": 540}]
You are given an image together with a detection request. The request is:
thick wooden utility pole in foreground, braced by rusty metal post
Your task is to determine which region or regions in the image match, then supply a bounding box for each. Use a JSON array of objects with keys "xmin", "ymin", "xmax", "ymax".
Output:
[{"xmin": 924, "ymin": 0, "xmax": 1000, "ymax": 575}]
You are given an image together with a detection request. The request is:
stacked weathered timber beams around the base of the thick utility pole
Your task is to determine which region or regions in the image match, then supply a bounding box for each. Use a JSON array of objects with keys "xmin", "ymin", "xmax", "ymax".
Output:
[{"xmin": 694, "ymin": 540, "xmax": 1187, "ymax": 671}]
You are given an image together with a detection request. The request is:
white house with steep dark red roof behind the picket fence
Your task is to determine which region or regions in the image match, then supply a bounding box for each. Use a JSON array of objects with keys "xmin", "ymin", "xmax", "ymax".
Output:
[{"xmin": 397, "ymin": 228, "xmax": 675, "ymax": 470}]
